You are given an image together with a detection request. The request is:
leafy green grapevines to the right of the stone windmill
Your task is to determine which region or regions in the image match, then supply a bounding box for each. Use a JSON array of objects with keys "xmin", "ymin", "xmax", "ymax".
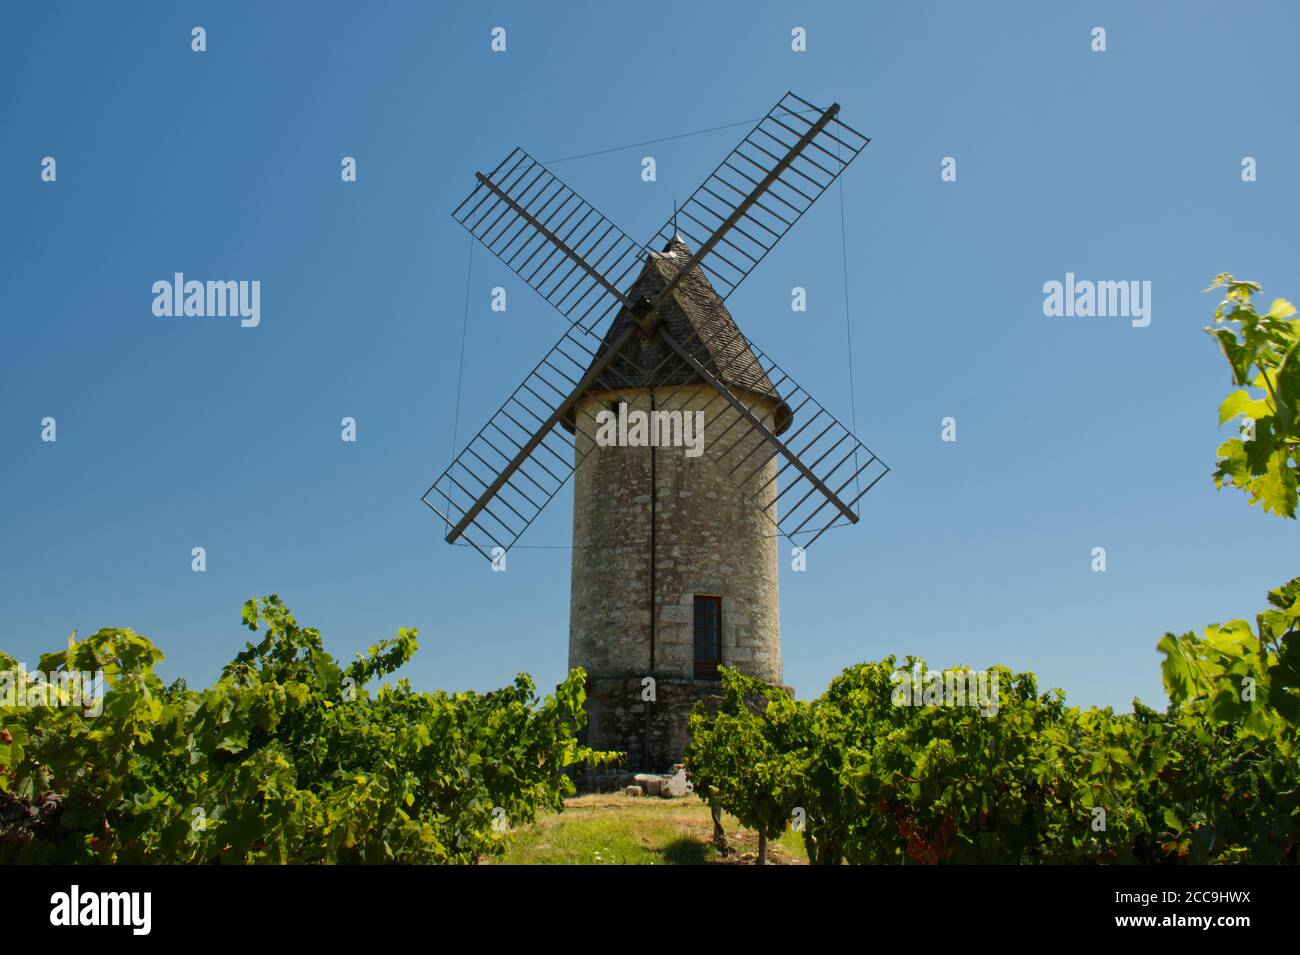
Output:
[{"xmin": 686, "ymin": 578, "xmax": 1300, "ymax": 864}]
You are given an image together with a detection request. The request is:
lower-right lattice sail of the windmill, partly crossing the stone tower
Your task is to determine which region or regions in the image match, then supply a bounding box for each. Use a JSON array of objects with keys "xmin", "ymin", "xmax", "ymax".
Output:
[{"xmin": 657, "ymin": 317, "xmax": 889, "ymax": 548}]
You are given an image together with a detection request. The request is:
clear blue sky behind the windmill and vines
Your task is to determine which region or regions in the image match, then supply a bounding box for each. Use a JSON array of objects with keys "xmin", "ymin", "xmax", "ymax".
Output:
[{"xmin": 0, "ymin": 3, "xmax": 1300, "ymax": 708}]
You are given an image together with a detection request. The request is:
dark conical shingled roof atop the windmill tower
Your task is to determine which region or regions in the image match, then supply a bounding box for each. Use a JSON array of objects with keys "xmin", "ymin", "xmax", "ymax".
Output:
[{"xmin": 564, "ymin": 235, "xmax": 792, "ymax": 434}]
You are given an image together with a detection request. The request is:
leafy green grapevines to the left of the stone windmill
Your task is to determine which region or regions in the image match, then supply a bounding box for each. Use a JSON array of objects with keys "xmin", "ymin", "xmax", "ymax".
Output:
[{"xmin": 0, "ymin": 596, "xmax": 601, "ymax": 863}]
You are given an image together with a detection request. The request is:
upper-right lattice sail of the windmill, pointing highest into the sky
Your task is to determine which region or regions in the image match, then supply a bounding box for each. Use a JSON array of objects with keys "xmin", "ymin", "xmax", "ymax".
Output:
[{"xmin": 649, "ymin": 92, "xmax": 871, "ymax": 300}]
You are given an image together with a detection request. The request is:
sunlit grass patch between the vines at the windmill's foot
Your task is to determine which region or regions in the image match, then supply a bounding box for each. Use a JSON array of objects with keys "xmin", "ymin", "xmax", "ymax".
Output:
[{"xmin": 493, "ymin": 793, "xmax": 807, "ymax": 865}]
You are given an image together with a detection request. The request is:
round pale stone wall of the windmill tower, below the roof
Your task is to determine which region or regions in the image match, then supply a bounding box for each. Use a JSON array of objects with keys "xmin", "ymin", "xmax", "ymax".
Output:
[{"xmin": 569, "ymin": 385, "xmax": 781, "ymax": 769}]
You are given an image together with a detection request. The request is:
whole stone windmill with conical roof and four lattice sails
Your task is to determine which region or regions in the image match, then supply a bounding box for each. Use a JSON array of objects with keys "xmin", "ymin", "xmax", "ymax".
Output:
[{"xmin": 423, "ymin": 92, "xmax": 888, "ymax": 769}]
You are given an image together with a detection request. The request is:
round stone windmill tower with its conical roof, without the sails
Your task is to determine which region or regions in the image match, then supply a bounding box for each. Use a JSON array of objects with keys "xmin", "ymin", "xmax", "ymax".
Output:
[{"xmin": 566, "ymin": 236, "xmax": 792, "ymax": 769}]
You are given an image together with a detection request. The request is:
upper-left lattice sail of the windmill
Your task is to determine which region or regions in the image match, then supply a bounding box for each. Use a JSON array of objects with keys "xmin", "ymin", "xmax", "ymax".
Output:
[{"xmin": 451, "ymin": 148, "xmax": 642, "ymax": 330}]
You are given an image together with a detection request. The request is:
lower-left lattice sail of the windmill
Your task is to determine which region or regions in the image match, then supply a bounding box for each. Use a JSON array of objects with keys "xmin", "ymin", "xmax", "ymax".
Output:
[{"xmin": 421, "ymin": 325, "xmax": 637, "ymax": 559}]
